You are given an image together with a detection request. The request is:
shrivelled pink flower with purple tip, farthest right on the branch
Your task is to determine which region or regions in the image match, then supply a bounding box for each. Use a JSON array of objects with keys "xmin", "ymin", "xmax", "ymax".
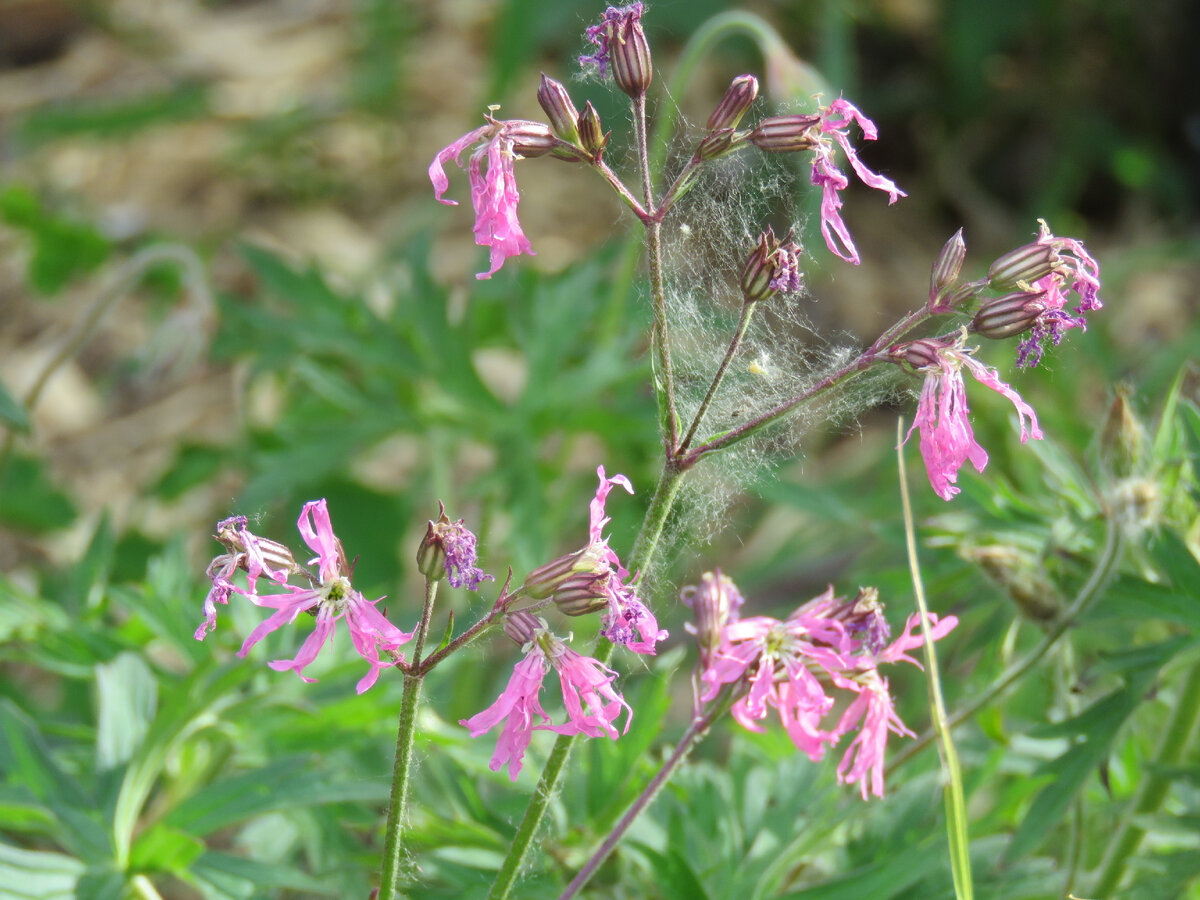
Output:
[{"xmin": 1016, "ymin": 221, "xmax": 1104, "ymax": 368}]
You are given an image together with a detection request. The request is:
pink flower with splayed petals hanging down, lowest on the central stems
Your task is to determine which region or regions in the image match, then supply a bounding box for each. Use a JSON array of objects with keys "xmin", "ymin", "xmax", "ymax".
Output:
[{"xmin": 460, "ymin": 611, "xmax": 632, "ymax": 781}]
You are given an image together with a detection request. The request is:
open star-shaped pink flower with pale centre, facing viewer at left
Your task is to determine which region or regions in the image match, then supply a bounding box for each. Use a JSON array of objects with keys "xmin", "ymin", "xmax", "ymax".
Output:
[{"xmin": 197, "ymin": 500, "xmax": 413, "ymax": 694}]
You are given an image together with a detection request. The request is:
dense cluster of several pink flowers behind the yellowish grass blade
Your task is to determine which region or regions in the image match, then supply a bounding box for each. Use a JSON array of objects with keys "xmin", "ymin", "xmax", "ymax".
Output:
[{"xmin": 684, "ymin": 572, "xmax": 958, "ymax": 799}]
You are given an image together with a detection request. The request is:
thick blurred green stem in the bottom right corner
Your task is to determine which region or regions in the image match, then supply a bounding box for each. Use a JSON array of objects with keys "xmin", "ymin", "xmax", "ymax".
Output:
[{"xmin": 1091, "ymin": 665, "xmax": 1200, "ymax": 898}]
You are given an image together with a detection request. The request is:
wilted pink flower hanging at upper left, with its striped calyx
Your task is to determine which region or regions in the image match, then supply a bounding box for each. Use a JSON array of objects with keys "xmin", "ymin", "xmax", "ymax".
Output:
[{"xmin": 430, "ymin": 118, "xmax": 556, "ymax": 278}]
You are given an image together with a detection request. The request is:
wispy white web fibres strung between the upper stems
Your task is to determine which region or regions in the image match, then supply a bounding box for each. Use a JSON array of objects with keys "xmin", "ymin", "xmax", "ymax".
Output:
[{"xmin": 660, "ymin": 120, "xmax": 894, "ymax": 558}]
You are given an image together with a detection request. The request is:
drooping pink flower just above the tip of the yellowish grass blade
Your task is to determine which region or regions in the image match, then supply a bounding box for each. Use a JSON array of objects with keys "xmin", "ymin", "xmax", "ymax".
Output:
[{"xmin": 890, "ymin": 332, "xmax": 1042, "ymax": 500}]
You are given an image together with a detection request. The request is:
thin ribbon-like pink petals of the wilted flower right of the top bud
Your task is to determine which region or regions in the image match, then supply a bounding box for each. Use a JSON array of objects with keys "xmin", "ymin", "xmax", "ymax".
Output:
[{"xmin": 811, "ymin": 98, "xmax": 908, "ymax": 265}]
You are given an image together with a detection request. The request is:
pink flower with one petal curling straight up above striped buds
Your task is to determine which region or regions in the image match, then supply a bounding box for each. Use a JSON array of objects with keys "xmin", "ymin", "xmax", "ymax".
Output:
[{"xmin": 524, "ymin": 466, "xmax": 667, "ymax": 654}]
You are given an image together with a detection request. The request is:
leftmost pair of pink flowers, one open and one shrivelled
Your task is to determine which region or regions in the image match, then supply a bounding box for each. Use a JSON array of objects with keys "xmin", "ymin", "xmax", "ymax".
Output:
[{"xmin": 196, "ymin": 500, "xmax": 413, "ymax": 694}]
